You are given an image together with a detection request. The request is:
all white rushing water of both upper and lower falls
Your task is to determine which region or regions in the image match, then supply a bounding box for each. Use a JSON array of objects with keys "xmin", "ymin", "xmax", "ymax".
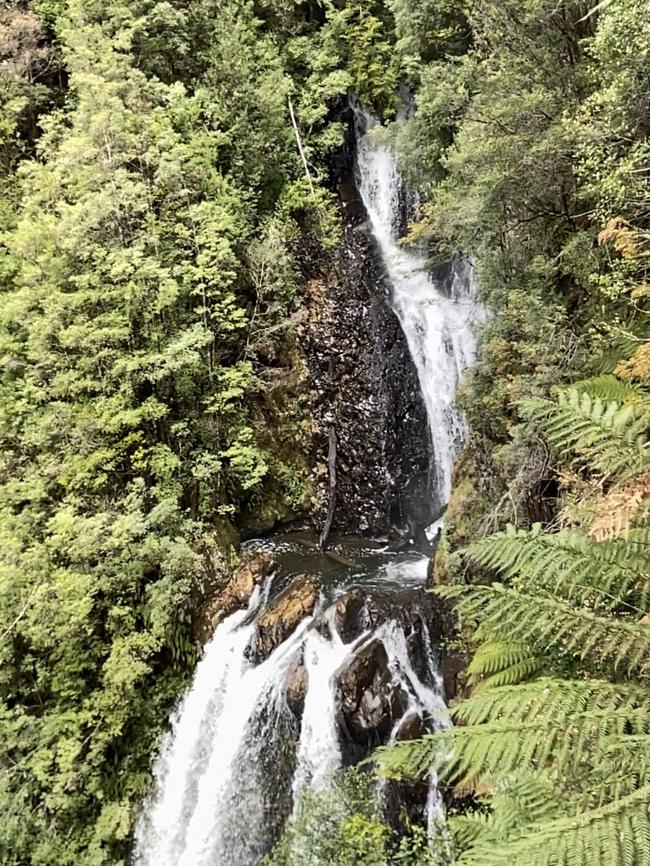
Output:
[{"xmin": 134, "ymin": 113, "xmax": 476, "ymax": 866}]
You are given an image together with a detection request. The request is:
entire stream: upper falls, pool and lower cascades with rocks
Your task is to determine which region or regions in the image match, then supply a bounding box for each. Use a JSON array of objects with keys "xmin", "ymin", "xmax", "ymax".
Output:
[{"xmin": 134, "ymin": 104, "xmax": 477, "ymax": 866}]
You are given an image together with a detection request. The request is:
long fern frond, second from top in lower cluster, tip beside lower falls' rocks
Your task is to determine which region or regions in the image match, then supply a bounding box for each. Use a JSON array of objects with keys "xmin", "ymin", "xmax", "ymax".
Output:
[{"xmin": 436, "ymin": 583, "xmax": 650, "ymax": 678}]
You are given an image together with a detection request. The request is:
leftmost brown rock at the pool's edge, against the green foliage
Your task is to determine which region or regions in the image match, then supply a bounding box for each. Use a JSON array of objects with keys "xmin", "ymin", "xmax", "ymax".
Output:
[{"xmin": 194, "ymin": 551, "xmax": 275, "ymax": 644}]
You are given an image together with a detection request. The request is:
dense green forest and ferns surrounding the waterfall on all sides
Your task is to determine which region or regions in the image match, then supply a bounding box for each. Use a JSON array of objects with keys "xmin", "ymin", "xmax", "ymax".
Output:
[{"xmin": 0, "ymin": 0, "xmax": 650, "ymax": 866}]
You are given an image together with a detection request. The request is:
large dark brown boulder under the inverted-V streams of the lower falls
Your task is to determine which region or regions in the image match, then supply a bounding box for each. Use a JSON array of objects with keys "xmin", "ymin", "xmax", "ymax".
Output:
[{"xmin": 336, "ymin": 639, "xmax": 408, "ymax": 752}]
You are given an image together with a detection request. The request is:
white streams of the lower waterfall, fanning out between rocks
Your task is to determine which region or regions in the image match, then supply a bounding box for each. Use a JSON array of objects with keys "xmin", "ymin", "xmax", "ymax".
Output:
[{"xmin": 134, "ymin": 580, "xmax": 444, "ymax": 866}]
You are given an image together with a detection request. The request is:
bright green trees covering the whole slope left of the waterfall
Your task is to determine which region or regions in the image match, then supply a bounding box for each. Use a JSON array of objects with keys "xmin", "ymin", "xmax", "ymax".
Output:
[{"xmin": 0, "ymin": 0, "xmax": 360, "ymax": 866}]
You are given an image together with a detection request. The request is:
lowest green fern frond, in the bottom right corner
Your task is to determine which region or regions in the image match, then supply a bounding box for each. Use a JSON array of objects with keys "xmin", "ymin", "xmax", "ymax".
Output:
[{"xmin": 457, "ymin": 786, "xmax": 650, "ymax": 866}]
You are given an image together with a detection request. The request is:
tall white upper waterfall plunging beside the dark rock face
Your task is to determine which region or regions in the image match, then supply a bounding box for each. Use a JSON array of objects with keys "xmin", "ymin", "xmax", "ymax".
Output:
[{"xmin": 357, "ymin": 111, "xmax": 478, "ymax": 507}]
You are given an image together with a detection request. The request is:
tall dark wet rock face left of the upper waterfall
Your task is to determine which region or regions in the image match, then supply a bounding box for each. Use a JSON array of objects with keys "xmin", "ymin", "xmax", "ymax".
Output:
[{"xmin": 300, "ymin": 150, "xmax": 433, "ymax": 537}]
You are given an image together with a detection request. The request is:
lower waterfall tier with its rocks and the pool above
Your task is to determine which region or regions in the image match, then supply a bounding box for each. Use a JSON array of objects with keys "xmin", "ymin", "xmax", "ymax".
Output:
[{"xmin": 135, "ymin": 536, "xmax": 454, "ymax": 866}]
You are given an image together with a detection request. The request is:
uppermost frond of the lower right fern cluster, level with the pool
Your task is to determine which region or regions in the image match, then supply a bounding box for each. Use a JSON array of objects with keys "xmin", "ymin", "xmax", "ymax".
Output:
[{"xmin": 465, "ymin": 526, "xmax": 650, "ymax": 612}]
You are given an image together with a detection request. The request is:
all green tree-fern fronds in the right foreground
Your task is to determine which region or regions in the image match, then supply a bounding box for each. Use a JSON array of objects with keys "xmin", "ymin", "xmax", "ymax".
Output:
[{"xmin": 378, "ymin": 380, "xmax": 650, "ymax": 866}]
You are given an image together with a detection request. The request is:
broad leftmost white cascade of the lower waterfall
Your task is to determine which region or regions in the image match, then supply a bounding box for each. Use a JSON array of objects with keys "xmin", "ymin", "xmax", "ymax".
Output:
[{"xmin": 134, "ymin": 592, "xmax": 311, "ymax": 866}]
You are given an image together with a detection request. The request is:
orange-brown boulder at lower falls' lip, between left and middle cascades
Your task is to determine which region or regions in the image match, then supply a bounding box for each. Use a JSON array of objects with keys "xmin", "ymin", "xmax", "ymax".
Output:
[{"xmin": 250, "ymin": 575, "xmax": 318, "ymax": 663}]
